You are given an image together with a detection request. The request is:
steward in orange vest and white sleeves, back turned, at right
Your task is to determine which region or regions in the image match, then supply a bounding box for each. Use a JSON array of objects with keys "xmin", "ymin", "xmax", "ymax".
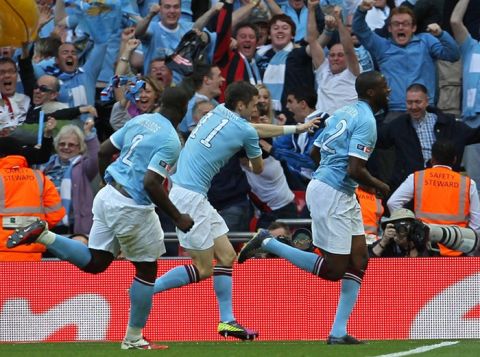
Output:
[{"xmin": 387, "ymin": 139, "xmax": 480, "ymax": 256}]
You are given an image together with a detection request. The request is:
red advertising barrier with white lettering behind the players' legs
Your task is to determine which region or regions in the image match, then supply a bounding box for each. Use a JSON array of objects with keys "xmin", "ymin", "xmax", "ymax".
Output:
[{"xmin": 0, "ymin": 258, "xmax": 480, "ymax": 342}]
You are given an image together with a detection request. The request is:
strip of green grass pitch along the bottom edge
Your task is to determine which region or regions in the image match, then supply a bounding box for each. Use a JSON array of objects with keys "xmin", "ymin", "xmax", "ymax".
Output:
[{"xmin": 0, "ymin": 339, "xmax": 480, "ymax": 357}]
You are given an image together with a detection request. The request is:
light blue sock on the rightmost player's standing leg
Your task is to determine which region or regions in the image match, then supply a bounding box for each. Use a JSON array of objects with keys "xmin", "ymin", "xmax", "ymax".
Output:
[{"xmin": 330, "ymin": 269, "xmax": 365, "ymax": 337}]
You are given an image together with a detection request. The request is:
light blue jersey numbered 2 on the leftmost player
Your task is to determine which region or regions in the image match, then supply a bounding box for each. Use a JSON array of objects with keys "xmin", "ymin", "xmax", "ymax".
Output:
[{"xmin": 105, "ymin": 113, "xmax": 181, "ymax": 205}]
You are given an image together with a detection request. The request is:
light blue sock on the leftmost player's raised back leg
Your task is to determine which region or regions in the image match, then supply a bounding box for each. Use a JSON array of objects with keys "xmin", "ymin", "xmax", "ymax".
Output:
[{"xmin": 47, "ymin": 232, "xmax": 92, "ymax": 268}]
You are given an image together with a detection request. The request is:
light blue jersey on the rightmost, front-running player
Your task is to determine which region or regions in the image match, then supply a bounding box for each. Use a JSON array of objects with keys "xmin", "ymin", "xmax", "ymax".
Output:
[{"xmin": 313, "ymin": 101, "xmax": 377, "ymax": 194}]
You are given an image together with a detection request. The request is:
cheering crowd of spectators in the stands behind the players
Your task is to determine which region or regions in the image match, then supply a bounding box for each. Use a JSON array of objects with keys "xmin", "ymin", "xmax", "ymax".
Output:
[{"xmin": 0, "ymin": 0, "xmax": 480, "ymax": 256}]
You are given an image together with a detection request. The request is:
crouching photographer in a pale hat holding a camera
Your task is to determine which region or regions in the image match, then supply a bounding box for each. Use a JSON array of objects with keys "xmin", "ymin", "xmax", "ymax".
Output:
[{"xmin": 368, "ymin": 208, "xmax": 429, "ymax": 258}]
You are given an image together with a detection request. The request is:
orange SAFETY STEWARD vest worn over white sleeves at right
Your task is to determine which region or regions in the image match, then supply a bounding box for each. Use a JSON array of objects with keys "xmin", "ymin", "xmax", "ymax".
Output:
[{"xmin": 413, "ymin": 166, "xmax": 470, "ymax": 257}]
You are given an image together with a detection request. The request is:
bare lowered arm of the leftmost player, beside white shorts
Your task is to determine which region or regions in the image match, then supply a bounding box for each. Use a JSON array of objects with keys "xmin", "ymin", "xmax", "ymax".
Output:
[{"xmin": 143, "ymin": 170, "xmax": 193, "ymax": 232}]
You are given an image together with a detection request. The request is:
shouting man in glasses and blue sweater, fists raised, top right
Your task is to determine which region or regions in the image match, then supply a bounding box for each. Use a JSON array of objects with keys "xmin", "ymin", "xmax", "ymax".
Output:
[{"xmin": 352, "ymin": 0, "xmax": 460, "ymax": 121}]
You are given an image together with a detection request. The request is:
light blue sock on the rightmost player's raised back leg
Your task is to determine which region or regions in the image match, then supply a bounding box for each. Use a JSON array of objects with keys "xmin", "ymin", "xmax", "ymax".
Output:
[{"xmin": 262, "ymin": 238, "xmax": 323, "ymax": 275}]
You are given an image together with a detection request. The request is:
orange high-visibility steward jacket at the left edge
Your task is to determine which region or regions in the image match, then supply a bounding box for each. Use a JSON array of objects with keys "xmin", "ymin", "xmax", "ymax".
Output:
[{"xmin": 0, "ymin": 155, "xmax": 65, "ymax": 261}]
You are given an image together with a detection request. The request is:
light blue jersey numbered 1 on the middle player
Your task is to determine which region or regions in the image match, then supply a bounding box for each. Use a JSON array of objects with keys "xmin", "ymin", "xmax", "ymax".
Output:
[{"xmin": 172, "ymin": 105, "xmax": 262, "ymax": 196}]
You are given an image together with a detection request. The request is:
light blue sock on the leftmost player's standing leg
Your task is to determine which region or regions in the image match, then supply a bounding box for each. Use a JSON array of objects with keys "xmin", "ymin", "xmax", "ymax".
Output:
[{"xmin": 128, "ymin": 277, "xmax": 153, "ymax": 328}]
